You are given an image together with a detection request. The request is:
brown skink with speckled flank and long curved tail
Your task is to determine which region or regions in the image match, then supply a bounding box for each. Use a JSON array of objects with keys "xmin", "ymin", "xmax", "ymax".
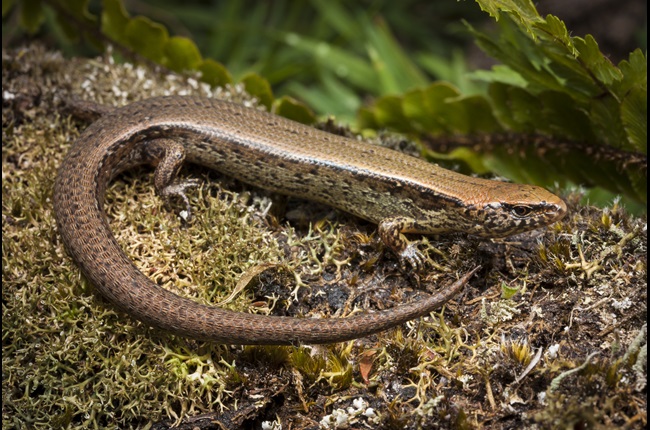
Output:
[{"xmin": 54, "ymin": 96, "xmax": 566, "ymax": 344}]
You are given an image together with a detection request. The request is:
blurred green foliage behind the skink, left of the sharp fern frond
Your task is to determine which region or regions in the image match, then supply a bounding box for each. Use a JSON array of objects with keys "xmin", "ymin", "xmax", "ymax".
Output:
[{"xmin": 3, "ymin": 0, "xmax": 486, "ymax": 122}]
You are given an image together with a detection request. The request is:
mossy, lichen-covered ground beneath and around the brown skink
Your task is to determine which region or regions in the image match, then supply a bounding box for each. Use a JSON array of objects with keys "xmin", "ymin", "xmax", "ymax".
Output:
[{"xmin": 2, "ymin": 47, "xmax": 647, "ymax": 428}]
